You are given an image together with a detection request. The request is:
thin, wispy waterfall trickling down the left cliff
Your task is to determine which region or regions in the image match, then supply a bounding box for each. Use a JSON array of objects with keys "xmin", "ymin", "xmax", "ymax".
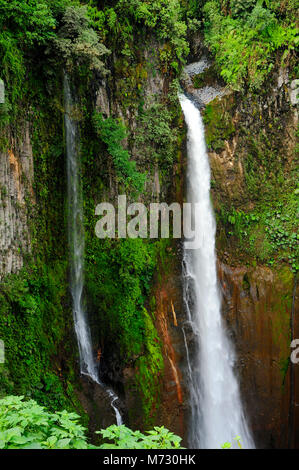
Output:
[{"xmin": 64, "ymin": 75, "xmax": 122, "ymax": 425}]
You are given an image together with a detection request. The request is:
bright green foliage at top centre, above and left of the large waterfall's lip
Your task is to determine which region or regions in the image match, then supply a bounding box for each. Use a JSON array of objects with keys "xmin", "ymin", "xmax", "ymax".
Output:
[{"xmin": 89, "ymin": 0, "xmax": 189, "ymax": 71}]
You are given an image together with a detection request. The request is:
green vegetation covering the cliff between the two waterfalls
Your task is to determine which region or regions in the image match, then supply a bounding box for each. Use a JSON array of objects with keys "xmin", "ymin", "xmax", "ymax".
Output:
[{"xmin": 82, "ymin": 86, "xmax": 177, "ymax": 420}]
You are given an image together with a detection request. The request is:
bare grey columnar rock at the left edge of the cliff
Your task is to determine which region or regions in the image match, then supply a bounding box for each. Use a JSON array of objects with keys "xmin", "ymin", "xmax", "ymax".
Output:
[{"xmin": 0, "ymin": 124, "xmax": 34, "ymax": 277}]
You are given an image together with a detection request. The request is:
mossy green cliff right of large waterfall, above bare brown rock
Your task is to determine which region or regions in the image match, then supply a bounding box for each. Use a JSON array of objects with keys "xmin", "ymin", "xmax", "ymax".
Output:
[{"xmin": 204, "ymin": 93, "xmax": 298, "ymax": 272}]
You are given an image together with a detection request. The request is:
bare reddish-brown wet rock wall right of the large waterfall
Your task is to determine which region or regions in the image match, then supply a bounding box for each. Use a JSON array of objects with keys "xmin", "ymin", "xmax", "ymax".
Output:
[{"xmin": 219, "ymin": 263, "xmax": 299, "ymax": 448}]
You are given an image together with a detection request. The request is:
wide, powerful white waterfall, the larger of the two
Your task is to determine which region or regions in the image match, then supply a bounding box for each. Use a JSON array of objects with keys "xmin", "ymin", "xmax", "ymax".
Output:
[{"xmin": 180, "ymin": 95, "xmax": 254, "ymax": 449}]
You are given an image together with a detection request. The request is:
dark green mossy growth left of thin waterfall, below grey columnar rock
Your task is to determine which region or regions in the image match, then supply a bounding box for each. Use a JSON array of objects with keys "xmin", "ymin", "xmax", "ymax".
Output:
[{"xmin": 0, "ymin": 262, "xmax": 82, "ymax": 420}]
